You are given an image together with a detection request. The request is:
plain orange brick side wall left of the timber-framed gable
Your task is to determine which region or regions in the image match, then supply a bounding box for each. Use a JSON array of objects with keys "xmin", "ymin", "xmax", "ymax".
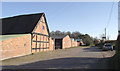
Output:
[{"xmin": 1, "ymin": 34, "xmax": 31, "ymax": 60}]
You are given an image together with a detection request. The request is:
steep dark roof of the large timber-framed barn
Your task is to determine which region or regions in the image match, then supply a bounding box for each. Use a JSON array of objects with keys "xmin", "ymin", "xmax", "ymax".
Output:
[{"xmin": 0, "ymin": 13, "xmax": 49, "ymax": 35}]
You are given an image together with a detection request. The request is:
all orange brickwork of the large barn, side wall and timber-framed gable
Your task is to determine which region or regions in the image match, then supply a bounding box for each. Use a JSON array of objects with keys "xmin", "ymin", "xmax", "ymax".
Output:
[{"xmin": 0, "ymin": 15, "xmax": 52, "ymax": 59}]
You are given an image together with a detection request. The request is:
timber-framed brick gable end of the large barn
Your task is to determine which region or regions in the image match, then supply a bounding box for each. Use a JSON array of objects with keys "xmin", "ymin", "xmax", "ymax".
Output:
[{"xmin": 32, "ymin": 16, "xmax": 52, "ymax": 53}]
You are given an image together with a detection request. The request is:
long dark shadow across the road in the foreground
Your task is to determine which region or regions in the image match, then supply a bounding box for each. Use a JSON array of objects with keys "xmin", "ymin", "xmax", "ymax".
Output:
[{"xmin": 3, "ymin": 57, "xmax": 109, "ymax": 69}]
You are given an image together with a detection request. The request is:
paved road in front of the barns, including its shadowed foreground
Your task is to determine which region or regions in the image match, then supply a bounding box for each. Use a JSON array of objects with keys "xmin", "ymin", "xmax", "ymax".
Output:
[{"xmin": 2, "ymin": 47, "xmax": 115, "ymax": 69}]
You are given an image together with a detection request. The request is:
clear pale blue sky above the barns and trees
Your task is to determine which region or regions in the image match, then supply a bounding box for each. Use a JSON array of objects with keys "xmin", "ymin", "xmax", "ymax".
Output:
[{"xmin": 2, "ymin": 2, "xmax": 118, "ymax": 40}]
